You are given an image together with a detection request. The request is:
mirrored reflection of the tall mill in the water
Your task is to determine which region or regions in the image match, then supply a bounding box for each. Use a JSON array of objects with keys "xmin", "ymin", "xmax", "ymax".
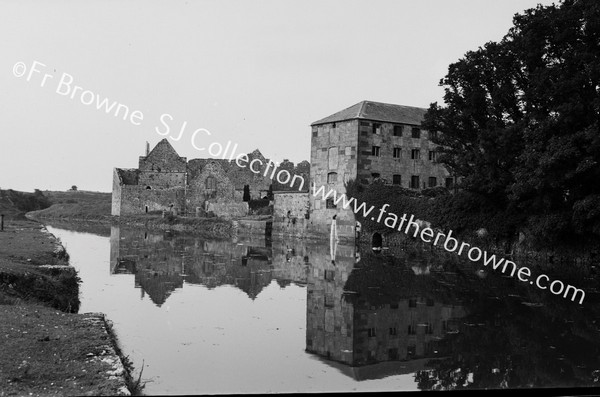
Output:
[{"xmin": 306, "ymin": 246, "xmax": 465, "ymax": 379}]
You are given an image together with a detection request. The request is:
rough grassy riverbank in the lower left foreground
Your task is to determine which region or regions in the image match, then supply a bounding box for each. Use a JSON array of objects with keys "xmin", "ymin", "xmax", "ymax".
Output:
[{"xmin": 0, "ymin": 218, "xmax": 130, "ymax": 395}]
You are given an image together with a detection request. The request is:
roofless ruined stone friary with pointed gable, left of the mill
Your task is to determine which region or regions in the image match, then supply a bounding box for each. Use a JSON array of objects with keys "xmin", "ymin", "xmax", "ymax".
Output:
[{"xmin": 112, "ymin": 139, "xmax": 309, "ymax": 216}]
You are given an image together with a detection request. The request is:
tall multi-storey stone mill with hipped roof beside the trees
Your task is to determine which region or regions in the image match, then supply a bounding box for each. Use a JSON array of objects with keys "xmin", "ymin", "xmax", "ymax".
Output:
[{"xmin": 273, "ymin": 101, "xmax": 454, "ymax": 238}]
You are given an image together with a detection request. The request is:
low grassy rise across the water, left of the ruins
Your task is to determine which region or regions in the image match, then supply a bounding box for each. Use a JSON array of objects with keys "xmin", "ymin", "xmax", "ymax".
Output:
[{"xmin": 27, "ymin": 190, "xmax": 112, "ymax": 220}]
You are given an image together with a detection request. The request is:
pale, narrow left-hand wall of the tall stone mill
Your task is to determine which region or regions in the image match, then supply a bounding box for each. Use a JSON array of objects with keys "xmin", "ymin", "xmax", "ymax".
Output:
[{"xmin": 308, "ymin": 120, "xmax": 358, "ymax": 238}]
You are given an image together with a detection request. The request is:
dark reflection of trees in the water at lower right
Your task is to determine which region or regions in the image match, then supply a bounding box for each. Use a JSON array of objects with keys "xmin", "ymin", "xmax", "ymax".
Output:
[{"xmin": 345, "ymin": 251, "xmax": 600, "ymax": 390}]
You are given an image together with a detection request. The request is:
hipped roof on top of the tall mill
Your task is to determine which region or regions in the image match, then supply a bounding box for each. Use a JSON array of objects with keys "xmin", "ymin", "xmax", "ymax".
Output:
[{"xmin": 311, "ymin": 101, "xmax": 427, "ymax": 125}]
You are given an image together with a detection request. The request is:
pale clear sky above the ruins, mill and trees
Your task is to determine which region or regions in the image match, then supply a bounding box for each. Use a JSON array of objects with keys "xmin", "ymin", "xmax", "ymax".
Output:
[{"xmin": 0, "ymin": 0, "xmax": 552, "ymax": 192}]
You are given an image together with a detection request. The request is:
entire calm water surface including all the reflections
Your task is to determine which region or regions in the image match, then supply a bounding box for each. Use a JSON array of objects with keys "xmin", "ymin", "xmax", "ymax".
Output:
[{"xmin": 48, "ymin": 226, "xmax": 600, "ymax": 394}]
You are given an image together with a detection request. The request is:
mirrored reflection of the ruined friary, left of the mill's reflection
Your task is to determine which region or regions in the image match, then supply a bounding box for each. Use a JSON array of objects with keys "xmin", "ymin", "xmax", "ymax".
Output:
[{"xmin": 110, "ymin": 226, "xmax": 306, "ymax": 306}]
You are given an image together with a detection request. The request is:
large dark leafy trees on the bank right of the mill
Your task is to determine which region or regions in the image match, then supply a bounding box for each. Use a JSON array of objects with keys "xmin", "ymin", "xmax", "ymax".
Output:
[{"xmin": 424, "ymin": 0, "xmax": 600, "ymax": 245}]
